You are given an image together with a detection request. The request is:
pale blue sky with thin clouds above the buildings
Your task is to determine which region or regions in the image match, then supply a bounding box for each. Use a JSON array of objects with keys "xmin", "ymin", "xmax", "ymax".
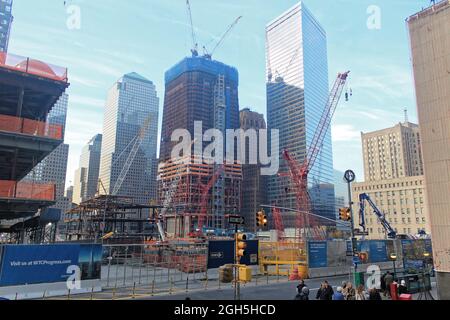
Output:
[{"xmin": 9, "ymin": 0, "xmax": 430, "ymax": 186}]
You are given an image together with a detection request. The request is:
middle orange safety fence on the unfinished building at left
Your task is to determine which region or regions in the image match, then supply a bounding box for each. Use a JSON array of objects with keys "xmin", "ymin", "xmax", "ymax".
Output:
[{"xmin": 0, "ymin": 115, "xmax": 63, "ymax": 140}]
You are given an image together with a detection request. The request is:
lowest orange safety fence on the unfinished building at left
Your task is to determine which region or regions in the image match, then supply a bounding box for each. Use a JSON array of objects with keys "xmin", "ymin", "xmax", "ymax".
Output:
[{"xmin": 0, "ymin": 180, "xmax": 55, "ymax": 201}]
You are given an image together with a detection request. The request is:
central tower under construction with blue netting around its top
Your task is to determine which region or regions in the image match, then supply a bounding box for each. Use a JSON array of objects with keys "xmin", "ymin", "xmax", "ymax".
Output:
[{"xmin": 159, "ymin": 56, "xmax": 242, "ymax": 235}]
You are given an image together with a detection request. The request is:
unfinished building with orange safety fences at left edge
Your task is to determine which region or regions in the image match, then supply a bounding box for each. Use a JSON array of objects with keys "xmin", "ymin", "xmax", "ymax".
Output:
[{"xmin": 0, "ymin": 55, "xmax": 69, "ymax": 243}]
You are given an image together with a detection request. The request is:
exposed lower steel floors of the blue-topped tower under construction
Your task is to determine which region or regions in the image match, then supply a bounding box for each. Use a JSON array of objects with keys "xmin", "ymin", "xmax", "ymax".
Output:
[{"xmin": 159, "ymin": 161, "xmax": 242, "ymax": 238}]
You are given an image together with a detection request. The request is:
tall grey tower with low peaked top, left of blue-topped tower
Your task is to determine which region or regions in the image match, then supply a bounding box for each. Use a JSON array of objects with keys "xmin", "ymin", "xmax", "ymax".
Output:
[{"xmin": 99, "ymin": 72, "xmax": 159, "ymax": 204}]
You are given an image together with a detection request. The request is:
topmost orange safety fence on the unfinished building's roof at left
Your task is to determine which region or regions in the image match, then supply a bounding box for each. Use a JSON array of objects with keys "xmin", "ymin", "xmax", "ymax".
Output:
[{"xmin": 0, "ymin": 52, "xmax": 67, "ymax": 82}]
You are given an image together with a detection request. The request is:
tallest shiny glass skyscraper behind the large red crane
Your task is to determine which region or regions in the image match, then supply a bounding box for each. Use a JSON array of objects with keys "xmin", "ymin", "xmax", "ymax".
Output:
[{"xmin": 266, "ymin": 3, "xmax": 335, "ymax": 227}]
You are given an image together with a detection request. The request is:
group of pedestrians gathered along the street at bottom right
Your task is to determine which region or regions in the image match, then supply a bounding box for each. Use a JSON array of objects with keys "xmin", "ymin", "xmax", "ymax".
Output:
[{"xmin": 295, "ymin": 272, "xmax": 408, "ymax": 300}]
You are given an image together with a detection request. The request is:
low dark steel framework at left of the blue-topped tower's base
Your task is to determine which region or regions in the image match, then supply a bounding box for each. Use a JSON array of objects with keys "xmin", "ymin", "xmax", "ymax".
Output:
[{"xmin": 64, "ymin": 195, "xmax": 160, "ymax": 243}]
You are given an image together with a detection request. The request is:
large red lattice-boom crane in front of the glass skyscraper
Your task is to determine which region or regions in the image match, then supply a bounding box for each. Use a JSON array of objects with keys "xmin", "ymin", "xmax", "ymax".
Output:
[{"xmin": 283, "ymin": 71, "xmax": 350, "ymax": 239}]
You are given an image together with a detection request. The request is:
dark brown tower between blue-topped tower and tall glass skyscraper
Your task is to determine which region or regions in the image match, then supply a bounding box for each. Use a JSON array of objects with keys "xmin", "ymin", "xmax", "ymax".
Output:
[{"xmin": 240, "ymin": 108, "xmax": 267, "ymax": 232}]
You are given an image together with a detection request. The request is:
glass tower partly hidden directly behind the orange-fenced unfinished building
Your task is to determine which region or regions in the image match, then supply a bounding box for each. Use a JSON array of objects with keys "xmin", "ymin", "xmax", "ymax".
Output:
[{"xmin": 24, "ymin": 93, "xmax": 69, "ymax": 213}]
